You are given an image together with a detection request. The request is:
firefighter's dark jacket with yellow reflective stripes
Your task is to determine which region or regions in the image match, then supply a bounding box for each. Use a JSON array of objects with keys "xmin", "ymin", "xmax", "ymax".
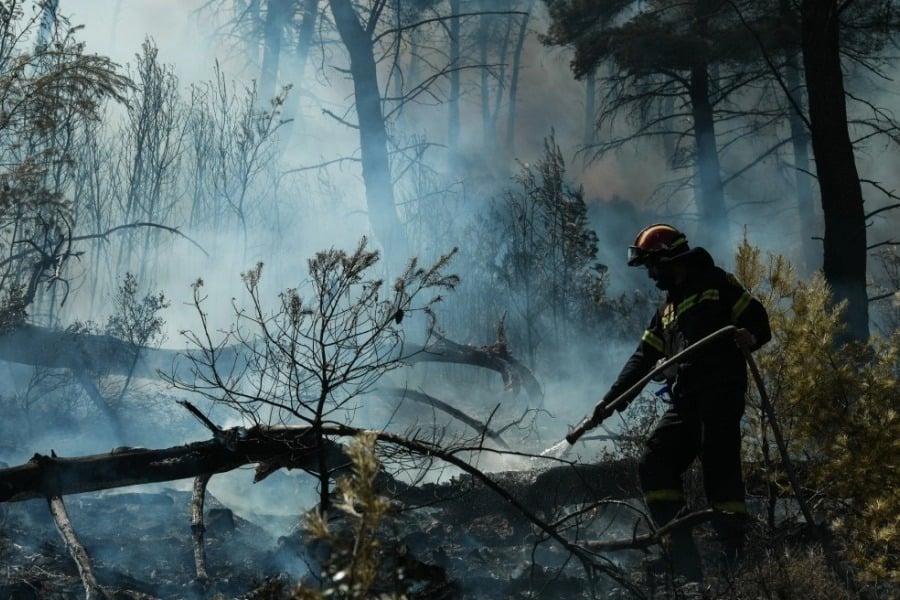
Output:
[{"xmin": 603, "ymin": 248, "xmax": 772, "ymax": 408}]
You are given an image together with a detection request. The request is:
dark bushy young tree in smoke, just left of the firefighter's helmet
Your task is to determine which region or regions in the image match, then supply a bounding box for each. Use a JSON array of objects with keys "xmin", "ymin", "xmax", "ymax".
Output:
[{"xmin": 475, "ymin": 135, "xmax": 606, "ymax": 364}]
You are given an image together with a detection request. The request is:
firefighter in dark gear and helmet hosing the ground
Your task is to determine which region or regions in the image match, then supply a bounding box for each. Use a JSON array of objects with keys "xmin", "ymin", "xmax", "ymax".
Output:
[{"xmin": 593, "ymin": 223, "xmax": 771, "ymax": 581}]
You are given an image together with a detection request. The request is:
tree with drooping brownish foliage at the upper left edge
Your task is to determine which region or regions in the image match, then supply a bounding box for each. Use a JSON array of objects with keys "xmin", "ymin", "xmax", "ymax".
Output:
[{"xmin": 0, "ymin": 0, "xmax": 130, "ymax": 321}]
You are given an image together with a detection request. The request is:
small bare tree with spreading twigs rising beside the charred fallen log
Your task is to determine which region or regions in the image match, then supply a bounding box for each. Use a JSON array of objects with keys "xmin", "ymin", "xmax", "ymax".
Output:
[{"xmin": 170, "ymin": 239, "xmax": 457, "ymax": 509}]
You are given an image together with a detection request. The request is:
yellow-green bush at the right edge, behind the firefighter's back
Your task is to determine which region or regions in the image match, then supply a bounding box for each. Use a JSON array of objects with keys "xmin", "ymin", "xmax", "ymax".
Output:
[{"xmin": 737, "ymin": 242, "xmax": 900, "ymax": 582}]
